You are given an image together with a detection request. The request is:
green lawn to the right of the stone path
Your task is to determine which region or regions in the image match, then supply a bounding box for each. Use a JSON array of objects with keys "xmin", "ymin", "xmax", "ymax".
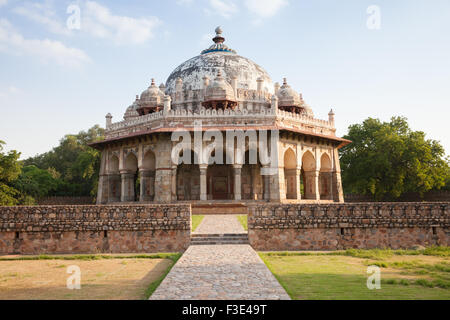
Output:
[{"xmin": 260, "ymin": 248, "xmax": 450, "ymax": 300}]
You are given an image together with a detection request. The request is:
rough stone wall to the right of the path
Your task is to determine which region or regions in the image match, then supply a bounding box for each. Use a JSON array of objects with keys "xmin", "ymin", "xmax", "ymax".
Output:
[{"xmin": 248, "ymin": 202, "xmax": 450, "ymax": 251}]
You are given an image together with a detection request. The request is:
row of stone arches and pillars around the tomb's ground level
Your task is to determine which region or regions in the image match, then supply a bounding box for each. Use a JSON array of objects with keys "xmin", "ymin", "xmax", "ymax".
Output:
[{"xmin": 101, "ymin": 136, "xmax": 343, "ymax": 203}]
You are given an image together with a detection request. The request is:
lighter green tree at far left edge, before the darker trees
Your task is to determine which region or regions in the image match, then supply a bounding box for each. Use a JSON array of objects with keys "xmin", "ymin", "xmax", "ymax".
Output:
[{"xmin": 0, "ymin": 140, "xmax": 21, "ymax": 206}]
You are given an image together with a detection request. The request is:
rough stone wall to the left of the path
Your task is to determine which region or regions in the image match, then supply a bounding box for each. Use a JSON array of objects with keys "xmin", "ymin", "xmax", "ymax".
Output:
[{"xmin": 0, "ymin": 205, "xmax": 191, "ymax": 254}]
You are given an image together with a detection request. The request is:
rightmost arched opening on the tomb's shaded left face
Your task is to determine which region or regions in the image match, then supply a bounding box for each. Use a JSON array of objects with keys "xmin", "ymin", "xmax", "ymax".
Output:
[{"xmin": 139, "ymin": 150, "xmax": 156, "ymax": 202}]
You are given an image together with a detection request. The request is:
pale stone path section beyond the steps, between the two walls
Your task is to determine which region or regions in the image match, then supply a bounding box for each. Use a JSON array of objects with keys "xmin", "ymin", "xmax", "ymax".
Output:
[{"xmin": 193, "ymin": 215, "xmax": 247, "ymax": 234}]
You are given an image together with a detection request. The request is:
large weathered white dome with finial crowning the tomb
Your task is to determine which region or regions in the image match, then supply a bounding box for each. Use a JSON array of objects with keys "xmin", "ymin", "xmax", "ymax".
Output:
[{"xmin": 166, "ymin": 28, "xmax": 274, "ymax": 94}]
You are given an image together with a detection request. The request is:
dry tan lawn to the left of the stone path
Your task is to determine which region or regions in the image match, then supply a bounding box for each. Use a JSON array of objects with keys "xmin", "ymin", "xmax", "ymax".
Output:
[{"xmin": 0, "ymin": 253, "xmax": 181, "ymax": 300}]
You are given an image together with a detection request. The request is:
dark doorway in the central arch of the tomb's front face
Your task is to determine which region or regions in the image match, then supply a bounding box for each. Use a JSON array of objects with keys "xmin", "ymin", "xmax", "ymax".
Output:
[{"xmin": 207, "ymin": 165, "xmax": 234, "ymax": 200}]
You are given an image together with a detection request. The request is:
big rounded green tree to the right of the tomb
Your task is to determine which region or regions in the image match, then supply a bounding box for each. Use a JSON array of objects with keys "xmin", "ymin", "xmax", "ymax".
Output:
[{"xmin": 341, "ymin": 117, "xmax": 450, "ymax": 200}]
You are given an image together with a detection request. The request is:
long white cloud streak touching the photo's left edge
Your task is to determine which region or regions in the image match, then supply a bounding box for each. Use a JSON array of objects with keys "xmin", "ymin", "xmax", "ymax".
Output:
[{"xmin": 0, "ymin": 19, "xmax": 91, "ymax": 67}]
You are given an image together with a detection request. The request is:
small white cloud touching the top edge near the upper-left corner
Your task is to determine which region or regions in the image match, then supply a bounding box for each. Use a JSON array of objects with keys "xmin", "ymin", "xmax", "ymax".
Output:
[{"xmin": 13, "ymin": 0, "xmax": 70, "ymax": 35}]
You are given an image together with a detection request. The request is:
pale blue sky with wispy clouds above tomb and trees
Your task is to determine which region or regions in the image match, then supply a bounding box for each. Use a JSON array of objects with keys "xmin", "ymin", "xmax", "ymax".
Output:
[{"xmin": 0, "ymin": 0, "xmax": 450, "ymax": 159}]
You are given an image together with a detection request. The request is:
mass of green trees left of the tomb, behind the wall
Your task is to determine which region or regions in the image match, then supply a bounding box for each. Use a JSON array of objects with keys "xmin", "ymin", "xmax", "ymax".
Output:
[{"xmin": 0, "ymin": 126, "xmax": 104, "ymax": 205}]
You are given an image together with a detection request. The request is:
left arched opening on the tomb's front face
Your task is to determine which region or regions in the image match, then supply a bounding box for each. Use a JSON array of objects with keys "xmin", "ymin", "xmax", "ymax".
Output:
[{"xmin": 177, "ymin": 150, "xmax": 200, "ymax": 201}]
